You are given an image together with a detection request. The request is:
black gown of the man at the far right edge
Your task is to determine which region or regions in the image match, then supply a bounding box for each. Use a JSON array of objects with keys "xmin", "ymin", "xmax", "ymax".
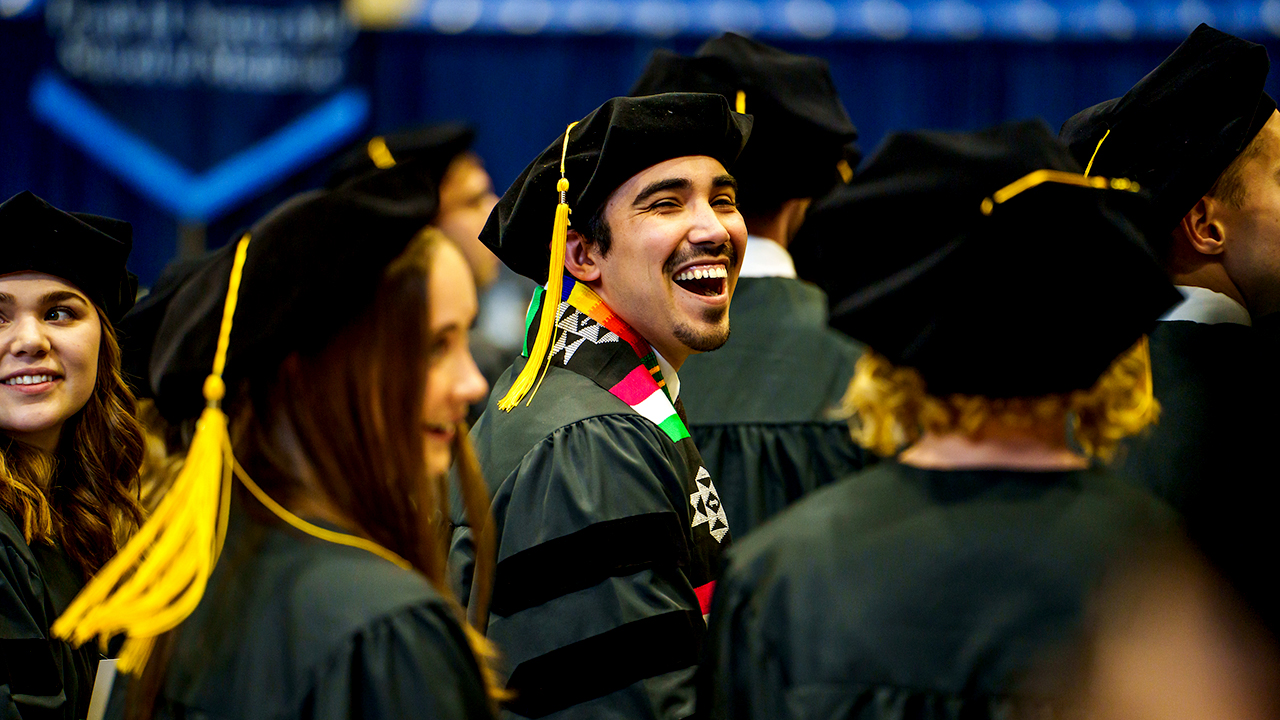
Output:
[{"xmin": 1116, "ymin": 320, "xmax": 1280, "ymax": 630}]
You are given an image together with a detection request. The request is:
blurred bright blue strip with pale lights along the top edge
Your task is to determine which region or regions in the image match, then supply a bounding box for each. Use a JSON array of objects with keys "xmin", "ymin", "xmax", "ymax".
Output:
[{"xmin": 406, "ymin": 0, "xmax": 1280, "ymax": 42}]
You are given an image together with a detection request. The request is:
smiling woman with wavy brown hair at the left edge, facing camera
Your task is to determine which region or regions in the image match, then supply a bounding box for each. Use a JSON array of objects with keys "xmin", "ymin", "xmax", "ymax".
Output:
[{"xmin": 0, "ymin": 192, "xmax": 142, "ymax": 720}]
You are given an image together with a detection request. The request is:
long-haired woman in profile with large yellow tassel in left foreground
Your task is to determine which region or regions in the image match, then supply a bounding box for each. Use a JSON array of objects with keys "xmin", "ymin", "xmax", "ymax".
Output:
[{"xmin": 55, "ymin": 175, "xmax": 497, "ymax": 719}]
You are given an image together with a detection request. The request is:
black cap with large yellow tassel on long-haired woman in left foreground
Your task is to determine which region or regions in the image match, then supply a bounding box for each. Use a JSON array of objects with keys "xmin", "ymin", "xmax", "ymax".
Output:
[{"xmin": 52, "ymin": 175, "xmax": 435, "ymax": 673}]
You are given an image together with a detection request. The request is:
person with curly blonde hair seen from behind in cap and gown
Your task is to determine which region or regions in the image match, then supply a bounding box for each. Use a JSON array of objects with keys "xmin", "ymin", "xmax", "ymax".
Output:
[{"xmin": 699, "ymin": 122, "xmax": 1178, "ymax": 720}]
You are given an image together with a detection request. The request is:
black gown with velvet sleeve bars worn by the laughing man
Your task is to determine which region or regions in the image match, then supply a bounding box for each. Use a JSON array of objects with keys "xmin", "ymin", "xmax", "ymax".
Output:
[{"xmin": 449, "ymin": 285, "xmax": 730, "ymax": 720}]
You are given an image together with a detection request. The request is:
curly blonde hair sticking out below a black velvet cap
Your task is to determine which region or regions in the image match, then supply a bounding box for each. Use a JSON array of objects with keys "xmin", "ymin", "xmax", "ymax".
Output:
[{"xmin": 844, "ymin": 336, "xmax": 1160, "ymax": 461}]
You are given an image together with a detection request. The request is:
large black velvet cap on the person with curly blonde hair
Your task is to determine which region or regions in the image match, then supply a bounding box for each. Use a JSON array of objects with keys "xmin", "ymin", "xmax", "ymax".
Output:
[{"xmin": 810, "ymin": 120, "xmax": 1181, "ymax": 397}]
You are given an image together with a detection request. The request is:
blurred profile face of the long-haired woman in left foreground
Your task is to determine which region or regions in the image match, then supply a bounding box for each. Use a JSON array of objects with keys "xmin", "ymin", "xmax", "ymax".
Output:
[{"xmin": 422, "ymin": 242, "xmax": 489, "ymax": 478}]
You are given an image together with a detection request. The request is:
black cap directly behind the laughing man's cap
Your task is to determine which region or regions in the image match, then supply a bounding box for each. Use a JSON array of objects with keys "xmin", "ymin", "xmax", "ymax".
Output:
[{"xmin": 631, "ymin": 32, "xmax": 859, "ymax": 213}]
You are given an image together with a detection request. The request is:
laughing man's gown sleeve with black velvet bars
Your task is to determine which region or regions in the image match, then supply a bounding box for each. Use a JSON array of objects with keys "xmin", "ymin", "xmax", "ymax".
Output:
[{"xmin": 481, "ymin": 415, "xmax": 707, "ymax": 720}]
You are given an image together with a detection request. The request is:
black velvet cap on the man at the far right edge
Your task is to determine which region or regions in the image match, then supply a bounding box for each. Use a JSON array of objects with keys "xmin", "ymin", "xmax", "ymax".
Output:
[{"xmin": 1060, "ymin": 24, "xmax": 1276, "ymax": 234}]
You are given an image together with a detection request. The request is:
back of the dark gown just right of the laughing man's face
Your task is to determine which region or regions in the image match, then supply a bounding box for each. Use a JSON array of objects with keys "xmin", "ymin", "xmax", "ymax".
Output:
[{"xmin": 680, "ymin": 278, "xmax": 864, "ymax": 537}]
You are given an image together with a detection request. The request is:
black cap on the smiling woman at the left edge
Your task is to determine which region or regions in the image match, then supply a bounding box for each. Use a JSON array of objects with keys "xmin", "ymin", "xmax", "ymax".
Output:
[{"xmin": 0, "ymin": 191, "xmax": 138, "ymax": 323}]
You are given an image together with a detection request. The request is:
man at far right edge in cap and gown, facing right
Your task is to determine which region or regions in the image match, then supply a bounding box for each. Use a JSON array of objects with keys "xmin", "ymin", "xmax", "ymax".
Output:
[{"xmin": 1060, "ymin": 24, "xmax": 1280, "ymax": 632}]
